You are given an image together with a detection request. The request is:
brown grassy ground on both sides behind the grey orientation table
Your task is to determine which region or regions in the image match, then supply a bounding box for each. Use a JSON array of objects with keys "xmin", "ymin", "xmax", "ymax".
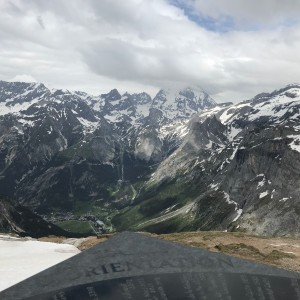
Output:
[{"xmin": 40, "ymin": 231, "xmax": 300, "ymax": 272}]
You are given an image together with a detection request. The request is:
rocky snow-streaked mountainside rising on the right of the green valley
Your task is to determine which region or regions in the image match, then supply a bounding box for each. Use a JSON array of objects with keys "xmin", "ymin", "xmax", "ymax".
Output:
[{"xmin": 114, "ymin": 85, "xmax": 300, "ymax": 236}]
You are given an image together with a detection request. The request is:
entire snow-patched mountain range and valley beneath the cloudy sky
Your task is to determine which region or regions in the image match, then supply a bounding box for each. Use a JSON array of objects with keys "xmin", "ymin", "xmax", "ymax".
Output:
[{"xmin": 0, "ymin": 81, "xmax": 300, "ymax": 236}]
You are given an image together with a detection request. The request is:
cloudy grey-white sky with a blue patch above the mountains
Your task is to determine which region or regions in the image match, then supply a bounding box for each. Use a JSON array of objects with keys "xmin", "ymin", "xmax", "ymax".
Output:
[{"xmin": 0, "ymin": 0, "xmax": 300, "ymax": 102}]
